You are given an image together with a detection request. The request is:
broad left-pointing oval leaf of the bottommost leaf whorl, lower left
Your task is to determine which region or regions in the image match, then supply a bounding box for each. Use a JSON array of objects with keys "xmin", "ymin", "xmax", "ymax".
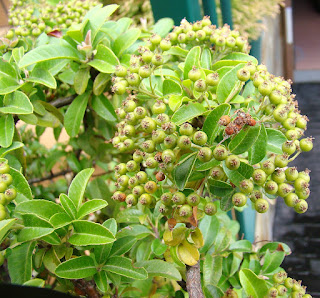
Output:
[{"xmin": 55, "ymin": 256, "xmax": 97, "ymax": 279}]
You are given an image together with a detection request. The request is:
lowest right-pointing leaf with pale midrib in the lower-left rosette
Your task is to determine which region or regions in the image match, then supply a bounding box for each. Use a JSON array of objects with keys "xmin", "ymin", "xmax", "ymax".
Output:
[{"xmin": 69, "ymin": 220, "xmax": 115, "ymax": 246}]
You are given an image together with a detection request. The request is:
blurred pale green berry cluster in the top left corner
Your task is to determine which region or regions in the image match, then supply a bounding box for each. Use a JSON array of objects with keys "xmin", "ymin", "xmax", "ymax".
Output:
[{"xmin": 6, "ymin": 0, "xmax": 98, "ymax": 39}]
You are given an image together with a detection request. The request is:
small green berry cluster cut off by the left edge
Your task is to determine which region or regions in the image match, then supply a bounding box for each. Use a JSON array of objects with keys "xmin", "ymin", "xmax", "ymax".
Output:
[{"xmin": 0, "ymin": 159, "xmax": 17, "ymax": 220}]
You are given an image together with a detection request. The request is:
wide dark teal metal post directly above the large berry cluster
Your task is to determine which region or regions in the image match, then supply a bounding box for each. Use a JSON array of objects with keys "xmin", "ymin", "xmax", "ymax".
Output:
[{"xmin": 150, "ymin": 0, "xmax": 202, "ymax": 26}]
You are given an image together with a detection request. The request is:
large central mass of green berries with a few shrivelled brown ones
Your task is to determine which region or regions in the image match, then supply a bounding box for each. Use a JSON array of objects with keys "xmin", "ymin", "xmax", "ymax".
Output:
[{"xmin": 112, "ymin": 18, "xmax": 313, "ymax": 222}]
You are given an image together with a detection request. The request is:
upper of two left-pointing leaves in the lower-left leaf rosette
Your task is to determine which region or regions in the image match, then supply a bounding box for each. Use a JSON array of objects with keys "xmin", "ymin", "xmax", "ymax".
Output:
[{"xmin": 15, "ymin": 199, "xmax": 64, "ymax": 221}]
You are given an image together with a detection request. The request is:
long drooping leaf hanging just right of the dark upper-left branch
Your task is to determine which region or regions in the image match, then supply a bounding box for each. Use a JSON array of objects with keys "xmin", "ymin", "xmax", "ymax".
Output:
[{"xmin": 64, "ymin": 91, "xmax": 91, "ymax": 137}]
